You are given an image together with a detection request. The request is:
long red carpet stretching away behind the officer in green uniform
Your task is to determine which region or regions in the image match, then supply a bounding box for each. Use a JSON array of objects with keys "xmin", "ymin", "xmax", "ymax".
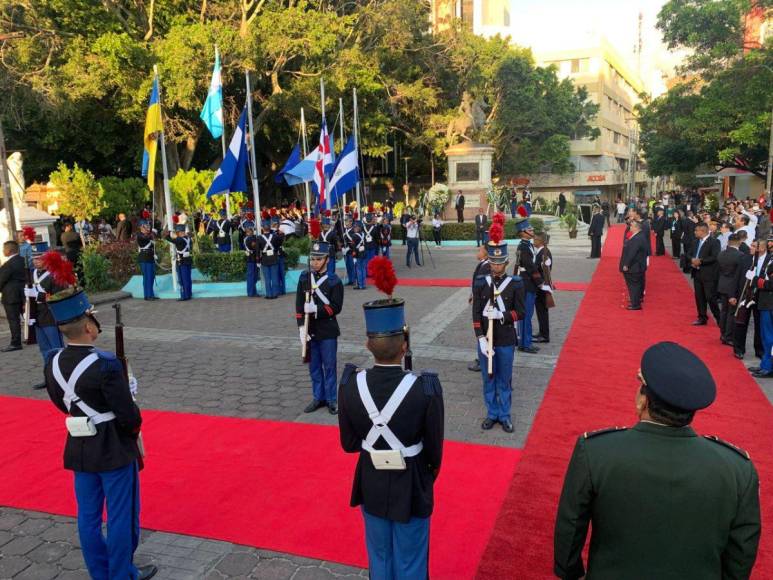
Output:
[{"xmin": 477, "ymin": 226, "xmax": 773, "ymax": 580}]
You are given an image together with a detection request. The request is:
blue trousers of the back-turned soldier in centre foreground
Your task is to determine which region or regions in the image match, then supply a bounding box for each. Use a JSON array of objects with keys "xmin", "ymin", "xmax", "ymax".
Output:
[{"xmin": 361, "ymin": 509, "xmax": 429, "ymax": 580}]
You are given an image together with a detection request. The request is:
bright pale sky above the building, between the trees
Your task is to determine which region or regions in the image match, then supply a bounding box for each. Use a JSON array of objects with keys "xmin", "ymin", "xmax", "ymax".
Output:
[{"xmin": 511, "ymin": 0, "xmax": 684, "ymax": 95}]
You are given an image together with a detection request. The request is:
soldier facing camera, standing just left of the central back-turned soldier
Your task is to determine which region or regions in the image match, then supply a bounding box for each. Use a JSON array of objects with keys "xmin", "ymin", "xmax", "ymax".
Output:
[{"xmin": 295, "ymin": 241, "xmax": 344, "ymax": 415}]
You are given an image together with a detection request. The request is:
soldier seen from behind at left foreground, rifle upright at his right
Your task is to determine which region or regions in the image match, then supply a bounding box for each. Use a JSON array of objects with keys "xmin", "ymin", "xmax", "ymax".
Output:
[{"xmin": 45, "ymin": 260, "xmax": 157, "ymax": 580}]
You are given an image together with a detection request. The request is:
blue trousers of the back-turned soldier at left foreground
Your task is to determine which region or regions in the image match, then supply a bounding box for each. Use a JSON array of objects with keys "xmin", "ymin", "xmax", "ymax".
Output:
[{"xmin": 75, "ymin": 461, "xmax": 140, "ymax": 580}]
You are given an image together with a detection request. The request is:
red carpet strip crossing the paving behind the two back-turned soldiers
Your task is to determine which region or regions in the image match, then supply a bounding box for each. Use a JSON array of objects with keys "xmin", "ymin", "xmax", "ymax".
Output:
[{"xmin": 0, "ymin": 397, "xmax": 520, "ymax": 578}]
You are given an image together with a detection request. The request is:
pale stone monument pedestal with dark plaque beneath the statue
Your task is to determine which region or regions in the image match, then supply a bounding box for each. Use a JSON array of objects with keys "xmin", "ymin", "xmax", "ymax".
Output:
[{"xmin": 443, "ymin": 141, "xmax": 494, "ymax": 220}]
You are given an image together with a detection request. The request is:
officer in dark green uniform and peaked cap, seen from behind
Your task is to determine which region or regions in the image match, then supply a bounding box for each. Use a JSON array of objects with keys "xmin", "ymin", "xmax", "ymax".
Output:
[{"xmin": 554, "ymin": 342, "xmax": 760, "ymax": 580}]
